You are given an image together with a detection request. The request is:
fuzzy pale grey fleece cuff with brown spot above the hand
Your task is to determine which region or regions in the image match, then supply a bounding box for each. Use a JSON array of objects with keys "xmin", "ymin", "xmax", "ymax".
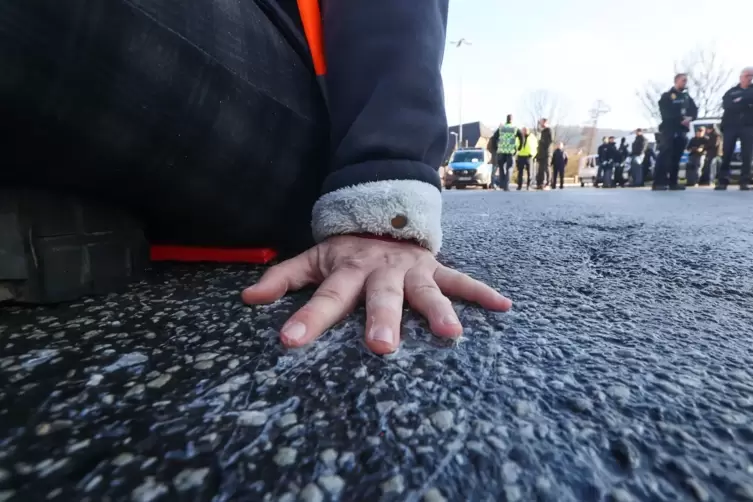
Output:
[{"xmin": 311, "ymin": 180, "xmax": 442, "ymax": 254}]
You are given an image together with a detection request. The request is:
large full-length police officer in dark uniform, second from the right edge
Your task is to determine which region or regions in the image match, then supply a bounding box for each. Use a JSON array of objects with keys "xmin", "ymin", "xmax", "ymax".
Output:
[{"xmin": 651, "ymin": 73, "xmax": 698, "ymax": 190}]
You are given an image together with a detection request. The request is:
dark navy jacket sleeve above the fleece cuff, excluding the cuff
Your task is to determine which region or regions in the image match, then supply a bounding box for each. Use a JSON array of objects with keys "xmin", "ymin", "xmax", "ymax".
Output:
[{"xmin": 322, "ymin": 0, "xmax": 448, "ymax": 193}]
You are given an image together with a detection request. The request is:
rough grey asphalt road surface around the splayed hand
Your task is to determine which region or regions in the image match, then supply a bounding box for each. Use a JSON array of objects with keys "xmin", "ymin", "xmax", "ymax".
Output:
[{"xmin": 0, "ymin": 189, "xmax": 753, "ymax": 502}]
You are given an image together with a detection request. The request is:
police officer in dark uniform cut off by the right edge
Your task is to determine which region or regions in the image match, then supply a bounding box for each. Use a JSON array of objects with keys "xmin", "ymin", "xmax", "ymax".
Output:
[{"xmin": 715, "ymin": 67, "xmax": 753, "ymax": 190}]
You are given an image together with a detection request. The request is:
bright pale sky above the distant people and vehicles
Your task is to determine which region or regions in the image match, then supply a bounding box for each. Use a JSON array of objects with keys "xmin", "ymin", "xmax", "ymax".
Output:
[{"xmin": 444, "ymin": 0, "xmax": 753, "ymax": 129}]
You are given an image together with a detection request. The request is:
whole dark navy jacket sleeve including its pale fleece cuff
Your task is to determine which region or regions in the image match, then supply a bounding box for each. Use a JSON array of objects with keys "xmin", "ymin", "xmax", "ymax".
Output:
[{"xmin": 312, "ymin": 0, "xmax": 449, "ymax": 253}]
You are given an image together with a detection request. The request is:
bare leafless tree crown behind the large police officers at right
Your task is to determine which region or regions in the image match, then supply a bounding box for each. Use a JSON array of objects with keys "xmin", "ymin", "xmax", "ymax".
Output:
[{"xmin": 636, "ymin": 47, "xmax": 733, "ymax": 124}]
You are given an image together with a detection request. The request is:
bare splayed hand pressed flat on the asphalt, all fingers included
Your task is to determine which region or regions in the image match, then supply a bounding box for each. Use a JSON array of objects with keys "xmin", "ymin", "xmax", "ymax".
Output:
[{"xmin": 242, "ymin": 235, "xmax": 512, "ymax": 354}]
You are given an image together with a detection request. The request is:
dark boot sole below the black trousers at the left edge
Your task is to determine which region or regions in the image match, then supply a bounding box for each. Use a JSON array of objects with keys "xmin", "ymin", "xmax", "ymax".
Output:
[{"xmin": 0, "ymin": 189, "xmax": 149, "ymax": 304}]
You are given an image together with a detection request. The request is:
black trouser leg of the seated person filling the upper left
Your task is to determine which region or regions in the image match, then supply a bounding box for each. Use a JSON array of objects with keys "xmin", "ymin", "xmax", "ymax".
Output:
[{"xmin": 0, "ymin": 0, "xmax": 329, "ymax": 249}]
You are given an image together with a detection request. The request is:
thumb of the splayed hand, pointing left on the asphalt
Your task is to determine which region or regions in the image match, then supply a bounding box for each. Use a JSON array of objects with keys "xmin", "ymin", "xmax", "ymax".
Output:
[{"xmin": 241, "ymin": 250, "xmax": 318, "ymax": 304}]
